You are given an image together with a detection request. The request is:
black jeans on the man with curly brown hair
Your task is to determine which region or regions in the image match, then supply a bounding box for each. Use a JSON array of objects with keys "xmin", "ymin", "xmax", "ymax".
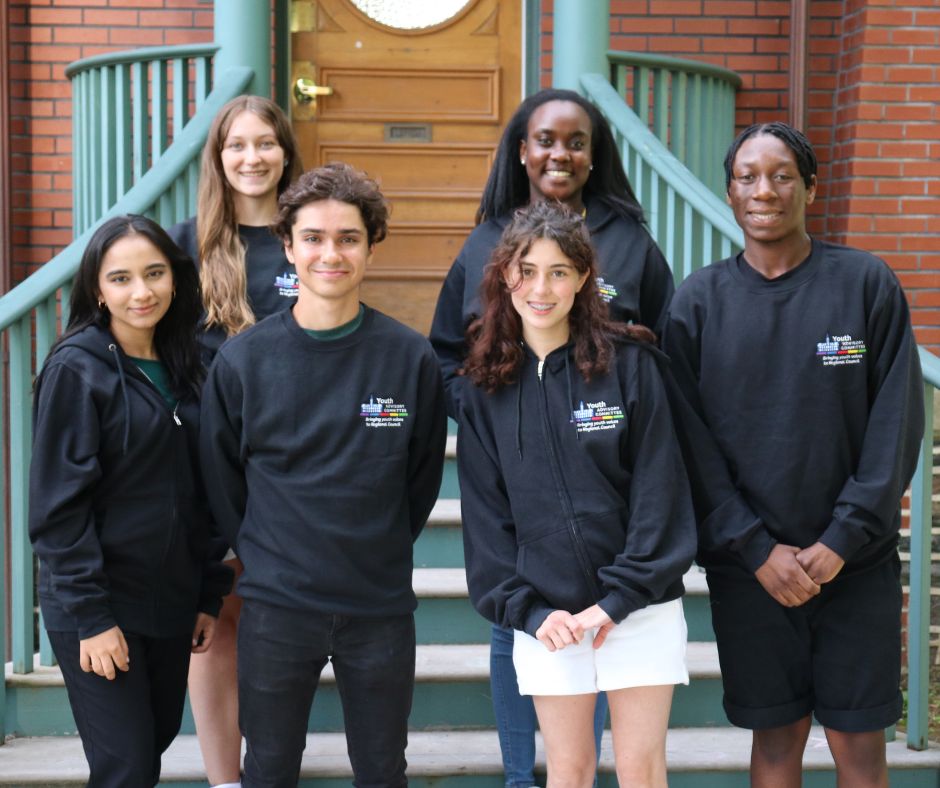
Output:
[{"xmin": 238, "ymin": 599, "xmax": 415, "ymax": 788}]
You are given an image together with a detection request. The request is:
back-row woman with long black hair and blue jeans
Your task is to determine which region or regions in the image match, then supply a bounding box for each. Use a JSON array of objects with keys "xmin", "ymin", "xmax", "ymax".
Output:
[{"xmin": 430, "ymin": 89, "xmax": 675, "ymax": 788}]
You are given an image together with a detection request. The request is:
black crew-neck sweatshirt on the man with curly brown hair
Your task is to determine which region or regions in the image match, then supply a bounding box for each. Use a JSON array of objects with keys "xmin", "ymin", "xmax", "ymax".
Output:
[{"xmin": 200, "ymin": 307, "xmax": 447, "ymax": 616}]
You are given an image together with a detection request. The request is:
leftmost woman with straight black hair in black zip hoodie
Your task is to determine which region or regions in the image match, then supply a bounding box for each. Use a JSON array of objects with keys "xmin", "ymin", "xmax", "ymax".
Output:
[{"xmin": 29, "ymin": 216, "xmax": 231, "ymax": 786}]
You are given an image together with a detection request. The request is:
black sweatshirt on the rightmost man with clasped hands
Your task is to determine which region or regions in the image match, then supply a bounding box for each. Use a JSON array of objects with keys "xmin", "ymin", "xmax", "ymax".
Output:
[{"xmin": 663, "ymin": 241, "xmax": 924, "ymax": 573}]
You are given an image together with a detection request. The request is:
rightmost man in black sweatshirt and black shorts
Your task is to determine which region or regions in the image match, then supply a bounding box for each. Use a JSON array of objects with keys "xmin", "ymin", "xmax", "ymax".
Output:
[{"xmin": 664, "ymin": 123, "xmax": 924, "ymax": 788}]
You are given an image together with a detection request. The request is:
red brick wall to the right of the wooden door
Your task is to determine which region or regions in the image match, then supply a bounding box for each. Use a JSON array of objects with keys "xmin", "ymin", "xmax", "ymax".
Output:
[{"xmin": 542, "ymin": 0, "xmax": 940, "ymax": 348}]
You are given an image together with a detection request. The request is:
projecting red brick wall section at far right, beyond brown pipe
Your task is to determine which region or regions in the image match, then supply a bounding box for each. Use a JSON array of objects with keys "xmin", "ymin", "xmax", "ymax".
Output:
[{"xmin": 825, "ymin": 0, "xmax": 940, "ymax": 348}]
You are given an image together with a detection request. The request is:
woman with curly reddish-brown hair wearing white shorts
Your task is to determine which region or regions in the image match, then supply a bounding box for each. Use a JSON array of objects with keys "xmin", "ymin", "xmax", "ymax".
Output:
[{"xmin": 457, "ymin": 202, "xmax": 696, "ymax": 788}]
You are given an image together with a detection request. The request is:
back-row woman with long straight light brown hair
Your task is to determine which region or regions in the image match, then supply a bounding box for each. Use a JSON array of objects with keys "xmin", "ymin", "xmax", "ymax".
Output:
[{"xmin": 170, "ymin": 96, "xmax": 303, "ymax": 786}]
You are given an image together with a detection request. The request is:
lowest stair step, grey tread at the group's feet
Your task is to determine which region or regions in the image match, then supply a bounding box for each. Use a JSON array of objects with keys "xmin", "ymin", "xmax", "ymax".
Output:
[{"xmin": 0, "ymin": 728, "xmax": 940, "ymax": 788}]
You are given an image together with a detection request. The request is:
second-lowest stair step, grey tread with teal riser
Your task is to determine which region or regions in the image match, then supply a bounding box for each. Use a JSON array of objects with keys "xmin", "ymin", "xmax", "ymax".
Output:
[{"xmin": 6, "ymin": 643, "xmax": 728, "ymax": 736}]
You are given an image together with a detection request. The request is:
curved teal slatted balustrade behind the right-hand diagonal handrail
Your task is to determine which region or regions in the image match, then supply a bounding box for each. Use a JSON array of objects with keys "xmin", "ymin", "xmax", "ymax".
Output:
[{"xmin": 607, "ymin": 50, "xmax": 741, "ymax": 197}]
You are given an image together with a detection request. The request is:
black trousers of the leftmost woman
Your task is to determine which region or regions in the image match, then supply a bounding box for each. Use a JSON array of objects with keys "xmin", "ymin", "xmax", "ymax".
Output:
[{"xmin": 49, "ymin": 632, "xmax": 192, "ymax": 788}]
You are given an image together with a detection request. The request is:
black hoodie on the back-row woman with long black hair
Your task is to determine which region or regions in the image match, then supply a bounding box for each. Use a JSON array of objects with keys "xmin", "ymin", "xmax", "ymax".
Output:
[{"xmin": 430, "ymin": 201, "xmax": 675, "ymax": 418}]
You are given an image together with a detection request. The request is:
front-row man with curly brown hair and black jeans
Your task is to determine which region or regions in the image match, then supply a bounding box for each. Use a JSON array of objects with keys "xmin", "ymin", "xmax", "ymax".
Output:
[{"xmin": 201, "ymin": 164, "xmax": 446, "ymax": 788}]
